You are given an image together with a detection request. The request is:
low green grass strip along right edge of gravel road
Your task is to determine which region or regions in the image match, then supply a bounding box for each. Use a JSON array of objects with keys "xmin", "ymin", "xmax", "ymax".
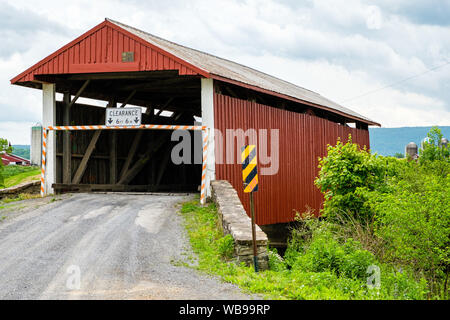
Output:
[{"xmin": 180, "ymin": 200, "xmax": 428, "ymax": 300}]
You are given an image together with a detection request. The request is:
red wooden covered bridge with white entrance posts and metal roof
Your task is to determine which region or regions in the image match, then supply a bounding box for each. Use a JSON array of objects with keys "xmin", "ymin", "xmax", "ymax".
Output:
[{"xmin": 11, "ymin": 19, "xmax": 379, "ymax": 225}]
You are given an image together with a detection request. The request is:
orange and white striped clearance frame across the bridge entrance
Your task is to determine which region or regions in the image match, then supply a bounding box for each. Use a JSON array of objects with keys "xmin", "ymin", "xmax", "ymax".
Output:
[{"xmin": 41, "ymin": 124, "xmax": 208, "ymax": 204}]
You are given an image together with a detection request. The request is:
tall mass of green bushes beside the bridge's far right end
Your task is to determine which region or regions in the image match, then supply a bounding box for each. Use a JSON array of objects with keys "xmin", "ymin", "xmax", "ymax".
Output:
[{"xmin": 314, "ymin": 128, "xmax": 450, "ymax": 299}]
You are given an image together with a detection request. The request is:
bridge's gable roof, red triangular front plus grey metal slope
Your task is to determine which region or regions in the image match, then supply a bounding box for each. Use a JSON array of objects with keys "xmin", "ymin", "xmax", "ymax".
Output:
[{"xmin": 11, "ymin": 19, "xmax": 379, "ymax": 125}]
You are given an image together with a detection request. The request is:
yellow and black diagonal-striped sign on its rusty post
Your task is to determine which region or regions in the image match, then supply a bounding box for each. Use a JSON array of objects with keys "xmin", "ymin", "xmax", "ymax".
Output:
[{"xmin": 242, "ymin": 144, "xmax": 258, "ymax": 272}]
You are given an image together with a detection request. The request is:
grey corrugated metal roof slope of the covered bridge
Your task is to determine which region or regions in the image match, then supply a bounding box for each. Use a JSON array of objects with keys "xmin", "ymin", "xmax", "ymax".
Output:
[{"xmin": 107, "ymin": 19, "xmax": 378, "ymax": 125}]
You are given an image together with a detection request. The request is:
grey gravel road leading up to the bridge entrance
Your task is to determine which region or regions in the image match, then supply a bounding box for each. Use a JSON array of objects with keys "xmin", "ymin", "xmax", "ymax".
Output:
[{"xmin": 0, "ymin": 194, "xmax": 252, "ymax": 299}]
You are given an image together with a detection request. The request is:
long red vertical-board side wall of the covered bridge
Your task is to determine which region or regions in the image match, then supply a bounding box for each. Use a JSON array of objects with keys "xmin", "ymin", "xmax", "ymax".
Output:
[{"xmin": 214, "ymin": 93, "xmax": 370, "ymax": 225}]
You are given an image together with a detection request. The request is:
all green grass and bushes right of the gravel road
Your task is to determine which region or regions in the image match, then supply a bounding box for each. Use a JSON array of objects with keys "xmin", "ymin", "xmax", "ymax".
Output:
[{"xmin": 181, "ymin": 128, "xmax": 450, "ymax": 299}]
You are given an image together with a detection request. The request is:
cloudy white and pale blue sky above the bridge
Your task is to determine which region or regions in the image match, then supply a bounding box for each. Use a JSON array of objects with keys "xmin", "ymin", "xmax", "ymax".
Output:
[{"xmin": 0, "ymin": 0, "xmax": 450, "ymax": 144}]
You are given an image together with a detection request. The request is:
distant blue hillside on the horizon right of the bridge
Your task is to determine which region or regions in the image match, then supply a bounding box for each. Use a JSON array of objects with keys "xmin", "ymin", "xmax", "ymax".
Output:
[{"xmin": 369, "ymin": 126, "xmax": 450, "ymax": 156}]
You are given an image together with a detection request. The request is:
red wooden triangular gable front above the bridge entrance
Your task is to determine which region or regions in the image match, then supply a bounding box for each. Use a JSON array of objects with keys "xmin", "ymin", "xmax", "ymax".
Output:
[{"xmin": 11, "ymin": 21, "xmax": 208, "ymax": 83}]
